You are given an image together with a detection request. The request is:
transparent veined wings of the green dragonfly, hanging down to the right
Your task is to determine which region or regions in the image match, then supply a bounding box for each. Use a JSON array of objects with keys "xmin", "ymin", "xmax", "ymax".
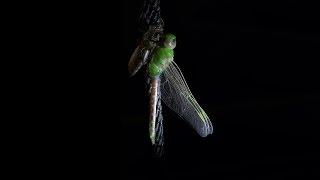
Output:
[{"xmin": 161, "ymin": 61, "xmax": 213, "ymax": 137}]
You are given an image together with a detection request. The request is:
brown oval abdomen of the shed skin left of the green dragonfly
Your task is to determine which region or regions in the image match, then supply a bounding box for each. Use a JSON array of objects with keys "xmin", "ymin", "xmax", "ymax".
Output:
[{"xmin": 128, "ymin": 45, "xmax": 150, "ymax": 76}]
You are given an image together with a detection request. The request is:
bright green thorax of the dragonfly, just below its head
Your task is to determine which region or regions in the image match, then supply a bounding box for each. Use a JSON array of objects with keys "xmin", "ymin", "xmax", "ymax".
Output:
[{"xmin": 149, "ymin": 47, "xmax": 174, "ymax": 77}]
